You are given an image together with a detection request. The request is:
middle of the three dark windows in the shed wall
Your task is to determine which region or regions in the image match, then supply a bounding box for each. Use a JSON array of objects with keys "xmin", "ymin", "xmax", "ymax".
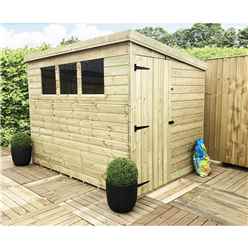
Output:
[{"xmin": 59, "ymin": 63, "xmax": 77, "ymax": 94}]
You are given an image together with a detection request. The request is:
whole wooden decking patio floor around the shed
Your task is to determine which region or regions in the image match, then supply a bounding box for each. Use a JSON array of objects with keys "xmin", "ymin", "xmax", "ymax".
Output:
[{"xmin": 0, "ymin": 150, "xmax": 248, "ymax": 226}]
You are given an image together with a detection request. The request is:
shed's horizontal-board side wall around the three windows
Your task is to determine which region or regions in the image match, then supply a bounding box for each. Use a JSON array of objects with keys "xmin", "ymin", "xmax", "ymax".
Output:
[{"xmin": 28, "ymin": 42, "xmax": 129, "ymax": 186}]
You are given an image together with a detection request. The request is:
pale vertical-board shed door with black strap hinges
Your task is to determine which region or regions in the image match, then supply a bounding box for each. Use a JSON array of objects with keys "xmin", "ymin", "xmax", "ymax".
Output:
[{"xmin": 131, "ymin": 55, "xmax": 168, "ymax": 193}]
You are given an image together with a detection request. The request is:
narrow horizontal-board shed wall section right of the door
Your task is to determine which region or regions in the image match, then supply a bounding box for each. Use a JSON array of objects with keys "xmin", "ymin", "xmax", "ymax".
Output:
[{"xmin": 168, "ymin": 60, "xmax": 205, "ymax": 181}]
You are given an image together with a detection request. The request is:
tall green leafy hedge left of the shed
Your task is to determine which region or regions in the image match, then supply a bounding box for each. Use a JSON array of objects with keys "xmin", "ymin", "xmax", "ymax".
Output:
[{"xmin": 0, "ymin": 45, "xmax": 48, "ymax": 146}]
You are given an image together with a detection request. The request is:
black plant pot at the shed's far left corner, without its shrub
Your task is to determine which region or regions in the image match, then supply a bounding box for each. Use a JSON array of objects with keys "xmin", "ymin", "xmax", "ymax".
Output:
[{"xmin": 10, "ymin": 146, "xmax": 32, "ymax": 166}]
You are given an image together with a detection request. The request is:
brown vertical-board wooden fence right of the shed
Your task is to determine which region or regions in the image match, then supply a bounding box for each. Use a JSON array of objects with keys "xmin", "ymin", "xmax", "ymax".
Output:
[{"xmin": 205, "ymin": 55, "xmax": 248, "ymax": 167}]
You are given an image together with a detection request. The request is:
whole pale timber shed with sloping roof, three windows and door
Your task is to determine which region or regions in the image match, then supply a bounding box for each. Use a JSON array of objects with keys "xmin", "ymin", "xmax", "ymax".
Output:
[{"xmin": 26, "ymin": 31, "xmax": 207, "ymax": 193}]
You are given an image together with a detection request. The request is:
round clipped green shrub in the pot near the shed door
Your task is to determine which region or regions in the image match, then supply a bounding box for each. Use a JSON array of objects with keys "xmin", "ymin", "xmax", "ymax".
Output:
[{"xmin": 107, "ymin": 158, "xmax": 138, "ymax": 186}]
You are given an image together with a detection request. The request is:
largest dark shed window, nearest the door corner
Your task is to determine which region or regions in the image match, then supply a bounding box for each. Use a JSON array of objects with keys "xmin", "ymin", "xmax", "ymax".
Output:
[{"xmin": 81, "ymin": 59, "xmax": 104, "ymax": 94}]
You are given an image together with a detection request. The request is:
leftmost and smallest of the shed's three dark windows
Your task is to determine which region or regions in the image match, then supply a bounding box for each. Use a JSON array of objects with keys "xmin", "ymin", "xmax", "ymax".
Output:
[{"xmin": 41, "ymin": 66, "xmax": 56, "ymax": 94}]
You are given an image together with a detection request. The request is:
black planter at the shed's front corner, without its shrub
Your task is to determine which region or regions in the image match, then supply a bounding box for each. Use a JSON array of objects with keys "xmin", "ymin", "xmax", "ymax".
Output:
[{"xmin": 106, "ymin": 181, "xmax": 138, "ymax": 213}]
